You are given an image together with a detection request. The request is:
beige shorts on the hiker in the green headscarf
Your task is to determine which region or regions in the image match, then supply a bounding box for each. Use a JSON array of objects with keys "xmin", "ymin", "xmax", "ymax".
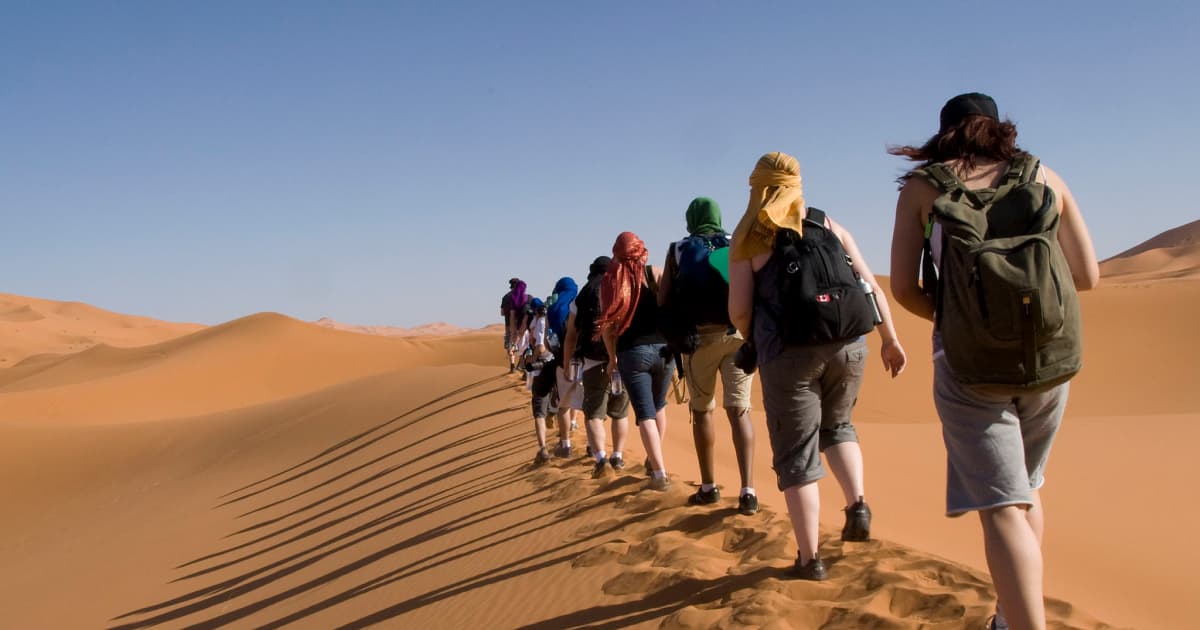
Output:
[{"xmin": 683, "ymin": 326, "xmax": 754, "ymax": 412}]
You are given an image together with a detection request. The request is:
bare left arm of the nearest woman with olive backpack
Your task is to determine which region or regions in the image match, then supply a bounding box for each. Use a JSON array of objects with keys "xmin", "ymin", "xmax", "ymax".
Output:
[{"xmin": 892, "ymin": 178, "xmax": 937, "ymax": 322}]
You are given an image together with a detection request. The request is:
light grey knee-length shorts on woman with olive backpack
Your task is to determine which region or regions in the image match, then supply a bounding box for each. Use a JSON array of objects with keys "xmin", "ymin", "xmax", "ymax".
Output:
[{"xmin": 934, "ymin": 356, "xmax": 1068, "ymax": 516}]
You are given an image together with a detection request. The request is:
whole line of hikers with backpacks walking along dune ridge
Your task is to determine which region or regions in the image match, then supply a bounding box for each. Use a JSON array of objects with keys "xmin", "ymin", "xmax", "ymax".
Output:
[{"xmin": 500, "ymin": 92, "xmax": 1099, "ymax": 629}]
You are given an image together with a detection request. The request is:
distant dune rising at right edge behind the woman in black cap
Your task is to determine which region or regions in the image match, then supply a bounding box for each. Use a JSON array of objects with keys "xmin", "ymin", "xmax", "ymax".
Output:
[{"xmin": 1100, "ymin": 221, "xmax": 1200, "ymax": 284}]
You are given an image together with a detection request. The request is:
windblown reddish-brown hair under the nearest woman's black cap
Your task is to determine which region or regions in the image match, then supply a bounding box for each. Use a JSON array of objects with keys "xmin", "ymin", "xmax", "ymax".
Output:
[{"xmin": 888, "ymin": 114, "xmax": 1025, "ymax": 186}]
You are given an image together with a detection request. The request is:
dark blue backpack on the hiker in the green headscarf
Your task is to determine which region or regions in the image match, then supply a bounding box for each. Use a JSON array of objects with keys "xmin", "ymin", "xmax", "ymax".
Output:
[{"xmin": 660, "ymin": 234, "xmax": 732, "ymax": 354}]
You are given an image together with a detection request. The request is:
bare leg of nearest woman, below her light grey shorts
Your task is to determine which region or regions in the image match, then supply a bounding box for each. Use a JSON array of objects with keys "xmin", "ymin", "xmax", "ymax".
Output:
[{"xmin": 979, "ymin": 505, "xmax": 1046, "ymax": 630}]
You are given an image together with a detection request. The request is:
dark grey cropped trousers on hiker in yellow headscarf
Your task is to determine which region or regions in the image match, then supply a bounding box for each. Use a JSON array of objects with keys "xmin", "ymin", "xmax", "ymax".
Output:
[{"xmin": 760, "ymin": 340, "xmax": 866, "ymax": 490}]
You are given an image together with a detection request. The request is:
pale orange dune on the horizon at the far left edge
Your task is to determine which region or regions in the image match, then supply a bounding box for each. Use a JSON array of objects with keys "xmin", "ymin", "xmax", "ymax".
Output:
[{"xmin": 0, "ymin": 293, "xmax": 204, "ymax": 367}]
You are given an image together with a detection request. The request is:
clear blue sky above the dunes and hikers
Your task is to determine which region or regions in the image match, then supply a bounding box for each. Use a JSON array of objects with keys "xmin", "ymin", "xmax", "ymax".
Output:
[{"xmin": 0, "ymin": 0, "xmax": 1200, "ymax": 326}]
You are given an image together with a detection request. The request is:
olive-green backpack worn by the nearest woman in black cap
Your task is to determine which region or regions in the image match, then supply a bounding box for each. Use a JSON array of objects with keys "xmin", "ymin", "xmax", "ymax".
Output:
[{"xmin": 917, "ymin": 154, "xmax": 1082, "ymax": 394}]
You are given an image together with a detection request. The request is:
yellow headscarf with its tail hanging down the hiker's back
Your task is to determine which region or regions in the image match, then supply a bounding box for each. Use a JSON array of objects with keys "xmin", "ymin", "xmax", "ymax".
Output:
[{"xmin": 730, "ymin": 151, "xmax": 804, "ymax": 260}]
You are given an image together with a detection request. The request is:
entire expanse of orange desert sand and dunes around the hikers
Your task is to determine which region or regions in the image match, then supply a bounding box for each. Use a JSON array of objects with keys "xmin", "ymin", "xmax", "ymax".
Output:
[{"xmin": 0, "ymin": 223, "xmax": 1200, "ymax": 629}]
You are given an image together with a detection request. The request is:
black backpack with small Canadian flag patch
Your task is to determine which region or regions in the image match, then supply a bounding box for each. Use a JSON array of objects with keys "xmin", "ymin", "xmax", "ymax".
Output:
[{"xmin": 772, "ymin": 208, "xmax": 875, "ymax": 346}]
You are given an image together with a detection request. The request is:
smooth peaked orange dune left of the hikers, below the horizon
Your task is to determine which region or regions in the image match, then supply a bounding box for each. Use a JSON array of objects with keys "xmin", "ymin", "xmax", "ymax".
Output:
[{"xmin": 0, "ymin": 313, "xmax": 506, "ymax": 422}]
